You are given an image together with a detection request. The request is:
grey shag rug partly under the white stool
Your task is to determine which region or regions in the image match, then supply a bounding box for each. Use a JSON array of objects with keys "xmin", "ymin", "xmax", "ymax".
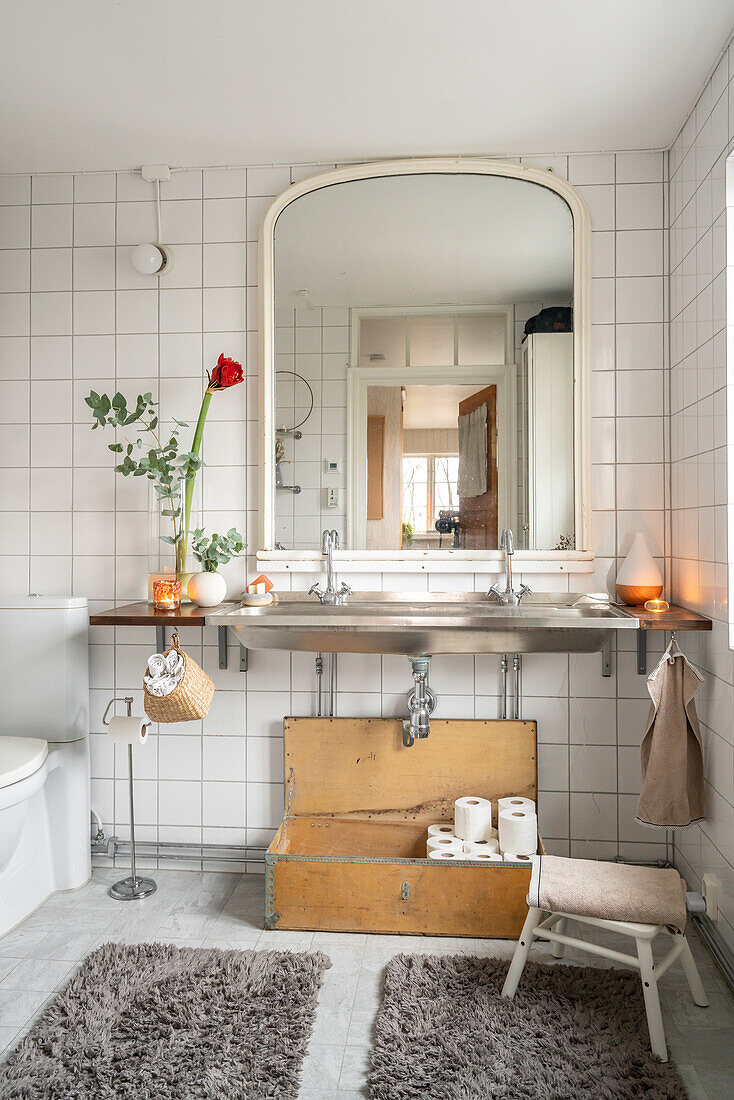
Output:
[{"xmin": 369, "ymin": 955, "xmax": 688, "ymax": 1100}]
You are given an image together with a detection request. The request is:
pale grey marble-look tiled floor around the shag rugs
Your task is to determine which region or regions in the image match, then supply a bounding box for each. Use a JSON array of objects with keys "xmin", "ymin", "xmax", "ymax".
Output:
[{"xmin": 0, "ymin": 868, "xmax": 734, "ymax": 1100}]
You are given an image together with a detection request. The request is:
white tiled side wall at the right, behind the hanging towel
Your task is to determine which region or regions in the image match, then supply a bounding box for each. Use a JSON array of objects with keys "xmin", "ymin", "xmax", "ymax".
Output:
[{"xmin": 669, "ymin": 40, "xmax": 734, "ymax": 949}]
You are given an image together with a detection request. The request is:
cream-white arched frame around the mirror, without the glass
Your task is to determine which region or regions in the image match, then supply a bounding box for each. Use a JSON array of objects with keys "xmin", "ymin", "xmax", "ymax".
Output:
[{"xmin": 258, "ymin": 157, "xmax": 594, "ymax": 573}]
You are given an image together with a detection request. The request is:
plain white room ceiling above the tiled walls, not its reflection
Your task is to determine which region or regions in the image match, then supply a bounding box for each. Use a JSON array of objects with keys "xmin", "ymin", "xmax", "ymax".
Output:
[{"xmin": 0, "ymin": 0, "xmax": 734, "ymax": 172}]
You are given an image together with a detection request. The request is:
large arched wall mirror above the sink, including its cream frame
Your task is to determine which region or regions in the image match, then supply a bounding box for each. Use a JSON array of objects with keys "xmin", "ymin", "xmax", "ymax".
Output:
[{"xmin": 261, "ymin": 161, "xmax": 590, "ymax": 557}]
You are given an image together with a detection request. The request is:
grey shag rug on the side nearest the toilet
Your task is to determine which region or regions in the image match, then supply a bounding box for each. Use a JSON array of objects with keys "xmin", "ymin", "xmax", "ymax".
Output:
[{"xmin": 0, "ymin": 944, "xmax": 331, "ymax": 1100}]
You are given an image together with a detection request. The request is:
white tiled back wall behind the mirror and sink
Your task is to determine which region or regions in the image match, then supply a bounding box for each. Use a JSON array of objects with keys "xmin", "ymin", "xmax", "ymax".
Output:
[{"xmin": 0, "ymin": 153, "xmax": 667, "ymax": 855}]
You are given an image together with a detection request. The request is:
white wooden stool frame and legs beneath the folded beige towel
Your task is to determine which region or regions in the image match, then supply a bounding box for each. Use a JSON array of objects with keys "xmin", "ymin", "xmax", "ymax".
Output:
[{"xmin": 502, "ymin": 909, "xmax": 709, "ymax": 1062}]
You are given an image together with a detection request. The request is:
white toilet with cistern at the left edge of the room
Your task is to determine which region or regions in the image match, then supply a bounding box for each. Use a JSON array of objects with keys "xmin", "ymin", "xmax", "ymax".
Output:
[{"xmin": 0, "ymin": 596, "xmax": 91, "ymax": 936}]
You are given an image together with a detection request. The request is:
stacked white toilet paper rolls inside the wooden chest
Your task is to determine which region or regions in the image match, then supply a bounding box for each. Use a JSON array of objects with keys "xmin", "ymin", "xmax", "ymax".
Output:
[{"xmin": 426, "ymin": 794, "xmax": 538, "ymax": 862}]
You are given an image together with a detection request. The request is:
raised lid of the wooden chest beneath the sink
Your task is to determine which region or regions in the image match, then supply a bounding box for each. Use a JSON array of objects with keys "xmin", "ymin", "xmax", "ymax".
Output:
[{"xmin": 283, "ymin": 718, "xmax": 538, "ymax": 823}]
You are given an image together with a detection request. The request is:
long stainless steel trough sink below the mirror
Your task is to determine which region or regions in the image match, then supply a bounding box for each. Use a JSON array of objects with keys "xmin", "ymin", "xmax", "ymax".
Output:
[{"xmin": 207, "ymin": 592, "xmax": 639, "ymax": 657}]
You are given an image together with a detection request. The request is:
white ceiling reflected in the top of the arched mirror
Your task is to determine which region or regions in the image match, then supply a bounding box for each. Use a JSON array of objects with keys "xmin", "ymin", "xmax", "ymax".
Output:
[{"xmin": 275, "ymin": 174, "xmax": 573, "ymax": 308}]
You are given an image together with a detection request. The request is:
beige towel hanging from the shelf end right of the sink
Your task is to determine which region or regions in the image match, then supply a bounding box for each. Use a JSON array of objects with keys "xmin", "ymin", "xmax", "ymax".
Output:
[{"xmin": 637, "ymin": 640, "xmax": 704, "ymax": 828}]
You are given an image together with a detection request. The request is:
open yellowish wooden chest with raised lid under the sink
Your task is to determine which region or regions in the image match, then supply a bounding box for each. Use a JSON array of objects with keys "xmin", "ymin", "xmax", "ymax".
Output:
[{"xmin": 265, "ymin": 718, "xmax": 537, "ymax": 938}]
